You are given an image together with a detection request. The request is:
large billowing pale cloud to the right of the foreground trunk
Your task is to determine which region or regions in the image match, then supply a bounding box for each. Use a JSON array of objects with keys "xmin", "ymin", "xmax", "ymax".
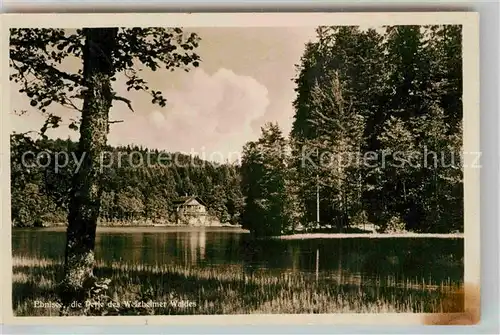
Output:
[{"xmin": 110, "ymin": 68, "xmax": 269, "ymax": 162}]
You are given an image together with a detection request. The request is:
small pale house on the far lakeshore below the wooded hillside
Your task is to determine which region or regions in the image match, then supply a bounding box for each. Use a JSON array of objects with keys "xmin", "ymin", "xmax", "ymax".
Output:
[{"xmin": 173, "ymin": 196, "xmax": 210, "ymax": 226}]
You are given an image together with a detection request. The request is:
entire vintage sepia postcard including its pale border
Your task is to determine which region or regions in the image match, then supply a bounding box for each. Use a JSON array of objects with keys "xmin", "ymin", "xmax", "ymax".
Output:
[{"xmin": 1, "ymin": 12, "xmax": 480, "ymax": 325}]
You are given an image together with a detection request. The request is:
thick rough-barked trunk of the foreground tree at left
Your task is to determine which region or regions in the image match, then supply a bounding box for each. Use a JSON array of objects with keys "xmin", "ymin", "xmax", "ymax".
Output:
[{"xmin": 61, "ymin": 28, "xmax": 117, "ymax": 314}]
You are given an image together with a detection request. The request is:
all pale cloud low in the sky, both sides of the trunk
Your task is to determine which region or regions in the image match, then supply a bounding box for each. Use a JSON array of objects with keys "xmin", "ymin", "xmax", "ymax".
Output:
[{"xmin": 10, "ymin": 68, "xmax": 270, "ymax": 161}]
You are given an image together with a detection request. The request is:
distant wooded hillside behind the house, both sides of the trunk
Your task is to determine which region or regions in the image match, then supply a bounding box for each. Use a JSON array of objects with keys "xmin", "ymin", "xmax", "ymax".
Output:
[{"xmin": 11, "ymin": 135, "xmax": 243, "ymax": 226}]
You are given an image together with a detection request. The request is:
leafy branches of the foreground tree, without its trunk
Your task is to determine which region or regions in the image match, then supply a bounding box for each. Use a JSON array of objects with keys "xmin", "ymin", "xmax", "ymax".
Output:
[{"xmin": 10, "ymin": 27, "xmax": 200, "ymax": 136}]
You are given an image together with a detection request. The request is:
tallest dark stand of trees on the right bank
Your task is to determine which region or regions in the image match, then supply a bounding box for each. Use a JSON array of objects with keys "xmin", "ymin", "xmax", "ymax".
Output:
[{"xmin": 290, "ymin": 25, "xmax": 463, "ymax": 233}]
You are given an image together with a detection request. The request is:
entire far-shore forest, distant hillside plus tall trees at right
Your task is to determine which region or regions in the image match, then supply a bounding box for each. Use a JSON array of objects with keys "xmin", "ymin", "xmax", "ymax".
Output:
[{"xmin": 11, "ymin": 25, "xmax": 463, "ymax": 236}]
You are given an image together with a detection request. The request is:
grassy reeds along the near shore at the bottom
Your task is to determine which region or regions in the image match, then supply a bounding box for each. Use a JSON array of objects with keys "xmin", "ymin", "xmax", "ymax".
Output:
[{"xmin": 12, "ymin": 257, "xmax": 463, "ymax": 316}]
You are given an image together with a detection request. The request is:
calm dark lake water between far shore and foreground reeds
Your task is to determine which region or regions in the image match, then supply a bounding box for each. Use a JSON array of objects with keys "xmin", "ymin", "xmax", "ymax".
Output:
[{"xmin": 12, "ymin": 228, "xmax": 464, "ymax": 285}]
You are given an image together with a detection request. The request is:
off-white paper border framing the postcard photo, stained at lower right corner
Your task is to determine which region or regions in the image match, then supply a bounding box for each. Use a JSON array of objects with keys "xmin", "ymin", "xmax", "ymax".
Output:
[{"xmin": 0, "ymin": 12, "xmax": 480, "ymax": 325}]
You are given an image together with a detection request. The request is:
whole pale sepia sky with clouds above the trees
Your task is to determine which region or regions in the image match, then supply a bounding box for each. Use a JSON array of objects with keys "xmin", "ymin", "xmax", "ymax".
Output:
[{"xmin": 10, "ymin": 27, "xmax": 315, "ymax": 161}]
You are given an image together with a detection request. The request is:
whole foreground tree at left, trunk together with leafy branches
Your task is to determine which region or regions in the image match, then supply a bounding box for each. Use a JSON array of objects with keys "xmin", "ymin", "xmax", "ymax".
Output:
[{"xmin": 10, "ymin": 28, "xmax": 199, "ymax": 316}]
